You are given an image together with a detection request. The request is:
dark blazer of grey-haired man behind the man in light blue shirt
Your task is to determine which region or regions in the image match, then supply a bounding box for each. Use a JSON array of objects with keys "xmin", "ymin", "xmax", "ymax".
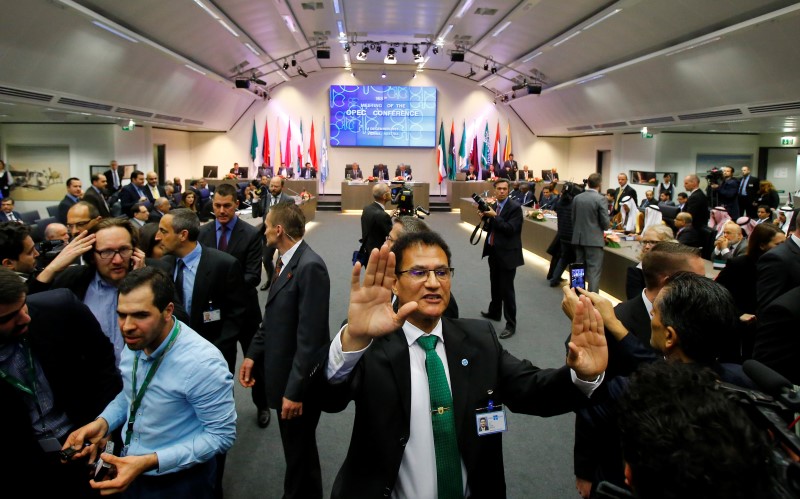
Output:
[{"xmin": 161, "ymin": 246, "xmax": 247, "ymax": 372}]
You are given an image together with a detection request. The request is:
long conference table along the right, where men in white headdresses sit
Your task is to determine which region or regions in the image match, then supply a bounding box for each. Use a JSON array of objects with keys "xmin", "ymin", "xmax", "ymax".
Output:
[{"xmin": 459, "ymin": 197, "xmax": 719, "ymax": 301}]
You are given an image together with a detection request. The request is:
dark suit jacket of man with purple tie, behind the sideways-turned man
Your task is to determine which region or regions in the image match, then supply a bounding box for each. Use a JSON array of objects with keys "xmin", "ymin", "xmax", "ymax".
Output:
[{"xmin": 197, "ymin": 219, "xmax": 263, "ymax": 337}]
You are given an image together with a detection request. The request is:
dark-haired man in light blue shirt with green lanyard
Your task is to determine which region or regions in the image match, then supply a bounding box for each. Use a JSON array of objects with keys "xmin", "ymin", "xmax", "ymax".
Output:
[{"xmin": 63, "ymin": 267, "xmax": 236, "ymax": 498}]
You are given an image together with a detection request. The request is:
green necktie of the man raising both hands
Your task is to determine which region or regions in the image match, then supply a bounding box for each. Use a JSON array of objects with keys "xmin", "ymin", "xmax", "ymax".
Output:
[{"xmin": 417, "ymin": 335, "xmax": 464, "ymax": 499}]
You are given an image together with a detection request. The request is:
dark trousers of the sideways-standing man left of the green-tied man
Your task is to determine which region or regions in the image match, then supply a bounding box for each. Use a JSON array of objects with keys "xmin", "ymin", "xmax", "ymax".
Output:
[{"xmin": 276, "ymin": 403, "xmax": 322, "ymax": 499}]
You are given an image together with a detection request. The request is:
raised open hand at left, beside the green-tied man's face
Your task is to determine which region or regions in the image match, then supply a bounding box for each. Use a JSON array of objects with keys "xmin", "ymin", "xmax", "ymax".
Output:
[{"xmin": 342, "ymin": 244, "xmax": 418, "ymax": 351}]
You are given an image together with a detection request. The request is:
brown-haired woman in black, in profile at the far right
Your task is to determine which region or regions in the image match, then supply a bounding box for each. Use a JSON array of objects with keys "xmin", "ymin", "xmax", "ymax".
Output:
[{"xmin": 716, "ymin": 224, "xmax": 786, "ymax": 362}]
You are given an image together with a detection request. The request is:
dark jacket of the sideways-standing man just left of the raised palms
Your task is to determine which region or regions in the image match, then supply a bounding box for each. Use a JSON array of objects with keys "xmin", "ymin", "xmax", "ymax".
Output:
[{"xmin": 246, "ymin": 241, "xmax": 331, "ymax": 408}]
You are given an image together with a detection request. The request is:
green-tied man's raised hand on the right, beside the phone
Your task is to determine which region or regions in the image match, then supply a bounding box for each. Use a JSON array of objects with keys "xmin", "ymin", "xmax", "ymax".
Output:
[{"xmin": 567, "ymin": 296, "xmax": 608, "ymax": 381}]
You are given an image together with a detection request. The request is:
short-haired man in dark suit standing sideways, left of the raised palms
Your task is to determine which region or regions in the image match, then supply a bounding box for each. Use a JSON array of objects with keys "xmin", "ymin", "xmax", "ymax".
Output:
[{"xmin": 239, "ymin": 203, "xmax": 331, "ymax": 499}]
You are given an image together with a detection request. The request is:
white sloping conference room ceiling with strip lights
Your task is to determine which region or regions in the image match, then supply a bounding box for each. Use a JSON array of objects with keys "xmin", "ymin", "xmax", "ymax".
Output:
[{"xmin": 0, "ymin": 0, "xmax": 800, "ymax": 136}]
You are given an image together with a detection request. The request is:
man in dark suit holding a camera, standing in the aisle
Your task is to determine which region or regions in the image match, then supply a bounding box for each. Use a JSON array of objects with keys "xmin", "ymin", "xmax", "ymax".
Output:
[{"xmin": 478, "ymin": 179, "xmax": 525, "ymax": 339}]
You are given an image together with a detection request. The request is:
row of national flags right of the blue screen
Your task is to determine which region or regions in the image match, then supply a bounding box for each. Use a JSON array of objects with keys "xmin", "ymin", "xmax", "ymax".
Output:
[{"xmin": 436, "ymin": 120, "xmax": 512, "ymax": 184}]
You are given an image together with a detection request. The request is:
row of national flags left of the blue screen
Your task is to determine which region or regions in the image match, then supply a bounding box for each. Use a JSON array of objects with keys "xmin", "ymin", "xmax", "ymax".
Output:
[{"xmin": 250, "ymin": 119, "xmax": 328, "ymax": 184}]
